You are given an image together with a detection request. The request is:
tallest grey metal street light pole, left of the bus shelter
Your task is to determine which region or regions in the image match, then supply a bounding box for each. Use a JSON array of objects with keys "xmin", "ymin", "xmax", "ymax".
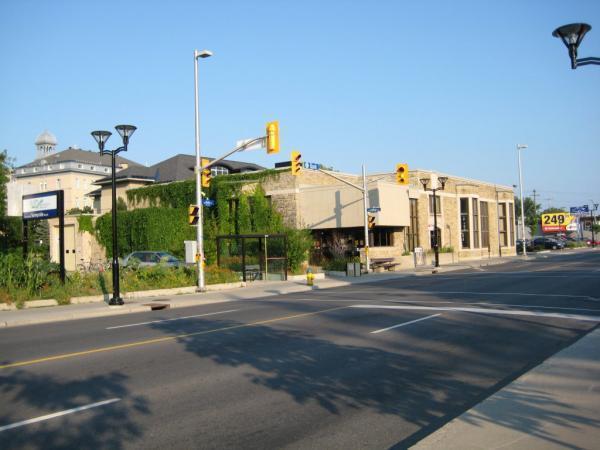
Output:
[{"xmin": 194, "ymin": 50, "xmax": 212, "ymax": 292}]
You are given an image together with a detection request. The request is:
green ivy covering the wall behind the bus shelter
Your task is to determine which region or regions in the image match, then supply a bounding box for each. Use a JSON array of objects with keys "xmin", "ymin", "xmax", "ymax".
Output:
[{"xmin": 95, "ymin": 170, "xmax": 312, "ymax": 271}]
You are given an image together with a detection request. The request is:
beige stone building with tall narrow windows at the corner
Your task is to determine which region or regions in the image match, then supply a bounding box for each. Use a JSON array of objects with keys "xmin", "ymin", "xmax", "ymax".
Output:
[{"xmin": 255, "ymin": 169, "xmax": 516, "ymax": 266}]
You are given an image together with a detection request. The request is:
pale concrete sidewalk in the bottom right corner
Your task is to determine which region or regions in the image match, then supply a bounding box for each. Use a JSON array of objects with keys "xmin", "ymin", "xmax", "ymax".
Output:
[{"xmin": 411, "ymin": 328, "xmax": 600, "ymax": 450}]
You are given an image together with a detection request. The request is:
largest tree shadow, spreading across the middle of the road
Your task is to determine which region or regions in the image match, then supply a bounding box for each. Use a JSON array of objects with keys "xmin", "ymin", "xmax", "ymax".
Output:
[{"xmin": 145, "ymin": 304, "xmax": 584, "ymax": 448}]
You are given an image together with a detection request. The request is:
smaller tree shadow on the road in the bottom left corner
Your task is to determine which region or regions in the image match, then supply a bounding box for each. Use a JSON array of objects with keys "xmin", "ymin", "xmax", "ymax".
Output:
[{"xmin": 0, "ymin": 370, "xmax": 150, "ymax": 449}]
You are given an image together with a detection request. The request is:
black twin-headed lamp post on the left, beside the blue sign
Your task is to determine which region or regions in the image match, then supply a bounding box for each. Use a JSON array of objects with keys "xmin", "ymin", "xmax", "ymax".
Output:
[{"xmin": 92, "ymin": 125, "xmax": 137, "ymax": 305}]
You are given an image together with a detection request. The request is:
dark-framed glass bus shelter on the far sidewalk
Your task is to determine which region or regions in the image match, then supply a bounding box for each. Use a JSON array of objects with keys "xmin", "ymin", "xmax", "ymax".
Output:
[{"xmin": 217, "ymin": 234, "xmax": 288, "ymax": 281}]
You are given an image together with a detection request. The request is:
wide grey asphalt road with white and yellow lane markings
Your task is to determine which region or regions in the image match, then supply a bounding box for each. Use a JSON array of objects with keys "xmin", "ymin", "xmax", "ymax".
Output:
[{"xmin": 0, "ymin": 252, "xmax": 600, "ymax": 449}]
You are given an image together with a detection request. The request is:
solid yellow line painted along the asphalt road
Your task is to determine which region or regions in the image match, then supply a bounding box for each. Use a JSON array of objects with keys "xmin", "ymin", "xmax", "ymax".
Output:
[{"xmin": 0, "ymin": 306, "xmax": 349, "ymax": 370}]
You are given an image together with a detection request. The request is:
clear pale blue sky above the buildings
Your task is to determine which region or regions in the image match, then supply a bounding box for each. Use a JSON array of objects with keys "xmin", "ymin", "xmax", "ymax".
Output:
[{"xmin": 0, "ymin": 0, "xmax": 600, "ymax": 208}]
